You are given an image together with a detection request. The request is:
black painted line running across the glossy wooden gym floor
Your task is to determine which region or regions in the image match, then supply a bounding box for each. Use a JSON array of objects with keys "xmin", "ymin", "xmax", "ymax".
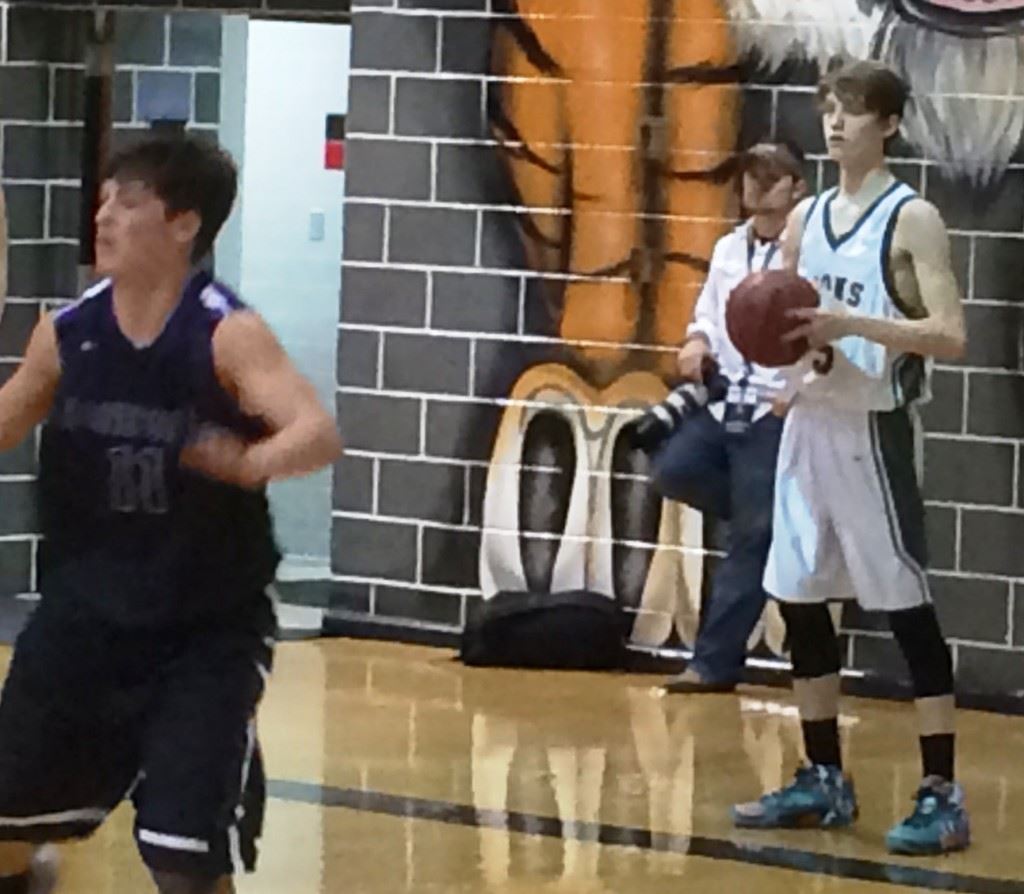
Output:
[{"xmin": 267, "ymin": 779, "xmax": 1024, "ymax": 894}]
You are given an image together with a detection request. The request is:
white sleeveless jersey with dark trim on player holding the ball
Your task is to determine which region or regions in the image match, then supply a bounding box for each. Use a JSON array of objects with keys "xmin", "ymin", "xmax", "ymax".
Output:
[{"xmin": 797, "ymin": 181, "xmax": 930, "ymax": 411}]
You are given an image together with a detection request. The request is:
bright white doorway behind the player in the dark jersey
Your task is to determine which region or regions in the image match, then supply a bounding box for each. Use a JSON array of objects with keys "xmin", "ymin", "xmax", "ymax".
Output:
[{"xmin": 216, "ymin": 16, "xmax": 351, "ymax": 574}]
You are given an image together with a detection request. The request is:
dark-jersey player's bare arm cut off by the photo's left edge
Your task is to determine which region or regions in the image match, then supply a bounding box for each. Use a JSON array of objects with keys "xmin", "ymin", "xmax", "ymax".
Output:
[{"xmin": 0, "ymin": 314, "xmax": 60, "ymax": 451}]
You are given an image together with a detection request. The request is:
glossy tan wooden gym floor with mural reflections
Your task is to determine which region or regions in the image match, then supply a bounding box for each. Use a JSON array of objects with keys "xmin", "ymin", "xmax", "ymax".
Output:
[{"xmin": 18, "ymin": 640, "xmax": 1024, "ymax": 894}]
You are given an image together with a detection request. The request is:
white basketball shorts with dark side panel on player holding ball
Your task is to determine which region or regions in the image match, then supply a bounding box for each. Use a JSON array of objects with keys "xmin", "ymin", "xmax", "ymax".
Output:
[{"xmin": 764, "ymin": 400, "xmax": 931, "ymax": 611}]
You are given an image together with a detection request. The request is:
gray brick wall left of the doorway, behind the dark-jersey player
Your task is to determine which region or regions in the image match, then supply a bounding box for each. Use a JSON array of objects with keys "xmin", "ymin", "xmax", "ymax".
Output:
[{"xmin": 0, "ymin": 3, "xmax": 228, "ymax": 595}]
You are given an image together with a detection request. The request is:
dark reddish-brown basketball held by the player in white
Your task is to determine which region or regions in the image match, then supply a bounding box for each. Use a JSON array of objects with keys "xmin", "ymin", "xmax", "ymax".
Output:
[{"xmin": 725, "ymin": 270, "xmax": 818, "ymax": 367}]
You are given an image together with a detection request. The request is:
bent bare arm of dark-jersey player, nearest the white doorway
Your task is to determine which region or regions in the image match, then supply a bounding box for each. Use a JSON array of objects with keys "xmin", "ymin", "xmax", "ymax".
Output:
[{"xmin": 182, "ymin": 311, "xmax": 342, "ymax": 487}]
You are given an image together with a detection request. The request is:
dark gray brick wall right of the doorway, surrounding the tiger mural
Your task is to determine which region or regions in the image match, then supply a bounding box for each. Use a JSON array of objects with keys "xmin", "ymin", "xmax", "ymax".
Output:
[{"xmin": 334, "ymin": 0, "xmax": 1024, "ymax": 691}]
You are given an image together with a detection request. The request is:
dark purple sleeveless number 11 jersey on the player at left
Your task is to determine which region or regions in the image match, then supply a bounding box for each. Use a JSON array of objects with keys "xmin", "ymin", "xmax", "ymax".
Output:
[{"xmin": 40, "ymin": 273, "xmax": 280, "ymax": 627}]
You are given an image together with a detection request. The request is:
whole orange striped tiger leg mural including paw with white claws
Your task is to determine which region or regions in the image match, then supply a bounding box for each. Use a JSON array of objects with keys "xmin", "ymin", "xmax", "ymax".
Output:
[{"xmin": 480, "ymin": 0, "xmax": 753, "ymax": 645}]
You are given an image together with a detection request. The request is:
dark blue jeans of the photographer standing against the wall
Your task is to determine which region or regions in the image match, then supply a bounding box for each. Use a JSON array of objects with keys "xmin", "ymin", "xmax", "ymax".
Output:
[{"xmin": 653, "ymin": 409, "xmax": 782, "ymax": 683}]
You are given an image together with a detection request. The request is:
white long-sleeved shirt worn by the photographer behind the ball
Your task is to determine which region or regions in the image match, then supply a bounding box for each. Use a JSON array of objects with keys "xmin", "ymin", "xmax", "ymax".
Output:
[{"xmin": 686, "ymin": 221, "xmax": 784, "ymax": 422}]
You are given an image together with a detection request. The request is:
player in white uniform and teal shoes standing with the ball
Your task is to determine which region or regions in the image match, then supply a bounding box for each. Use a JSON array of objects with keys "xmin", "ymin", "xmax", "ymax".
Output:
[{"xmin": 733, "ymin": 61, "xmax": 970, "ymax": 854}]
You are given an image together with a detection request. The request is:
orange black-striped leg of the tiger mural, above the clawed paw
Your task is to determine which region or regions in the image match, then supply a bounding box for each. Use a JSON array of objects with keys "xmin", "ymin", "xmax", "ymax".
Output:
[{"xmin": 492, "ymin": 0, "xmax": 739, "ymax": 384}]
